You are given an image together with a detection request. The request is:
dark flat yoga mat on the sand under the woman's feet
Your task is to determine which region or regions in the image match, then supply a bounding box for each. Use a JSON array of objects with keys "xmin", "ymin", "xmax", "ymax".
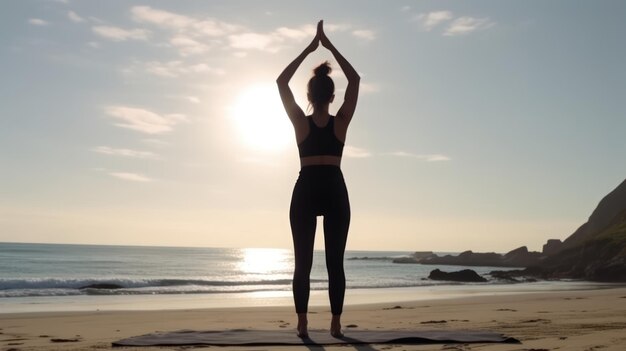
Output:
[{"xmin": 113, "ymin": 329, "xmax": 519, "ymax": 346}]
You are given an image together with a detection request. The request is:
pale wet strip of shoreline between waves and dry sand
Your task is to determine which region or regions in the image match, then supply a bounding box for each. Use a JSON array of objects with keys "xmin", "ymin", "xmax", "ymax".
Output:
[{"xmin": 0, "ymin": 281, "xmax": 626, "ymax": 316}]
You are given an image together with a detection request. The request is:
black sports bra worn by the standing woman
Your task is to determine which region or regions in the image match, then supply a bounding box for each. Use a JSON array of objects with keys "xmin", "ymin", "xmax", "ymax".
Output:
[{"xmin": 298, "ymin": 116, "xmax": 344, "ymax": 157}]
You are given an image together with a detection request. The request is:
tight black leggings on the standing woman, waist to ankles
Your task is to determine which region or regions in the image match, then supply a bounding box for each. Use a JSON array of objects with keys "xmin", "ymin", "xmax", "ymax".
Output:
[{"xmin": 289, "ymin": 166, "xmax": 350, "ymax": 315}]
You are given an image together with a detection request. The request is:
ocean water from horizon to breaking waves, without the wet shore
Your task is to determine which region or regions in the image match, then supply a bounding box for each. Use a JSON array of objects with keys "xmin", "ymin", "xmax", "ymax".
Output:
[{"xmin": 0, "ymin": 243, "xmax": 508, "ymax": 298}]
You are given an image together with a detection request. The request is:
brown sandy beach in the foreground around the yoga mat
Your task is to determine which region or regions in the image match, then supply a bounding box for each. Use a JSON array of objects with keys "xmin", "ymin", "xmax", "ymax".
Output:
[{"xmin": 0, "ymin": 287, "xmax": 626, "ymax": 351}]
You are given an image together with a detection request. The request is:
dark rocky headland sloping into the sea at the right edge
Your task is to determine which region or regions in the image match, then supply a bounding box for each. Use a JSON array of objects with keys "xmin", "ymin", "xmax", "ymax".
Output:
[{"xmin": 394, "ymin": 180, "xmax": 626, "ymax": 282}]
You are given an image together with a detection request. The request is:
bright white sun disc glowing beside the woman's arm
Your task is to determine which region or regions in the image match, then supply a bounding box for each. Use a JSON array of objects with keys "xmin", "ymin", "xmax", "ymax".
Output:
[{"xmin": 231, "ymin": 84, "xmax": 294, "ymax": 151}]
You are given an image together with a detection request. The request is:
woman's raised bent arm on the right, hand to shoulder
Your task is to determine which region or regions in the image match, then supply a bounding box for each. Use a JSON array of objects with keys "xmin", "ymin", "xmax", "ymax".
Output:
[{"xmin": 317, "ymin": 21, "xmax": 361, "ymax": 127}]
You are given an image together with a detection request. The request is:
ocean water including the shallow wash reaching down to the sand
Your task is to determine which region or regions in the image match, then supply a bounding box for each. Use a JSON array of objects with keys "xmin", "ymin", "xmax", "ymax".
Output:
[{"xmin": 0, "ymin": 243, "xmax": 604, "ymax": 313}]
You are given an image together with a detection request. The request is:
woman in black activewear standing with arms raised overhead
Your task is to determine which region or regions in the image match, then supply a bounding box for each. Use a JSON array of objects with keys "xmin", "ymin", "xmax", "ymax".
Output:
[{"xmin": 276, "ymin": 21, "xmax": 360, "ymax": 338}]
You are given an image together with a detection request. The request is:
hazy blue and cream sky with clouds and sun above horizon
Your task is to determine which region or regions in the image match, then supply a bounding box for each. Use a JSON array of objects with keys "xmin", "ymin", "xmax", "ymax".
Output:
[{"xmin": 0, "ymin": 0, "xmax": 626, "ymax": 252}]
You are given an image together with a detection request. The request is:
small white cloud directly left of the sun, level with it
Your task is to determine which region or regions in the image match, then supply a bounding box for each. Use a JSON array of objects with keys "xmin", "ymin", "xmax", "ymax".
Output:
[{"xmin": 105, "ymin": 106, "xmax": 187, "ymax": 134}]
